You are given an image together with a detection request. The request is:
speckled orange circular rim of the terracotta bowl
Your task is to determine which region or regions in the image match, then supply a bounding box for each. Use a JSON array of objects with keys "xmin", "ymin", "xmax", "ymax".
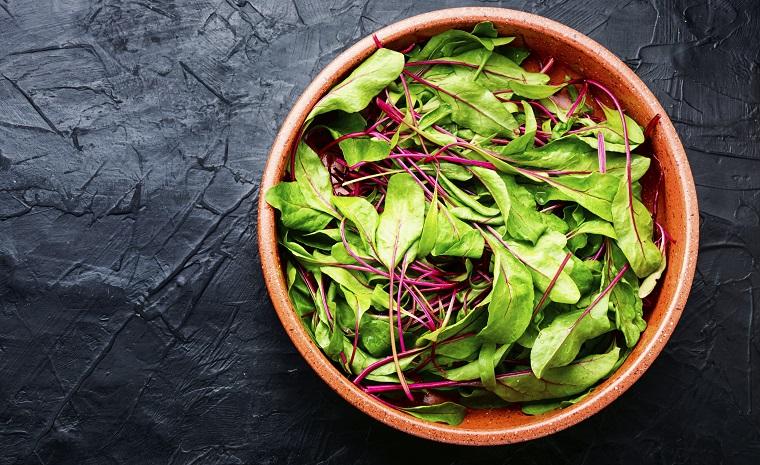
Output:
[{"xmin": 258, "ymin": 7, "xmax": 699, "ymax": 445}]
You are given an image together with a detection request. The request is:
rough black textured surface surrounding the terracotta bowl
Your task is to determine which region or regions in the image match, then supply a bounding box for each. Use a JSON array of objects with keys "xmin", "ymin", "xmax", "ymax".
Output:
[{"xmin": 0, "ymin": 0, "xmax": 760, "ymax": 465}]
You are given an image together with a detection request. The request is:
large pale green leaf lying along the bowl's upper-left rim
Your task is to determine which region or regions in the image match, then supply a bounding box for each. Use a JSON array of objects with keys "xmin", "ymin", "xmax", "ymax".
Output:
[{"xmin": 306, "ymin": 48, "xmax": 404, "ymax": 122}]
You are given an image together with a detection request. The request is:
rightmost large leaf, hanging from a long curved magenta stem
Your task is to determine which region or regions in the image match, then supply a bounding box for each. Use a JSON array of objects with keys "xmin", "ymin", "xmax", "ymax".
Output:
[{"xmin": 612, "ymin": 179, "xmax": 662, "ymax": 278}]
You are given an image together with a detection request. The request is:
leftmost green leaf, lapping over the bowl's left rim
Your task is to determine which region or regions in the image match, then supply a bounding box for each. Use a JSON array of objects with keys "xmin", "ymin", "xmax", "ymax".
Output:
[{"xmin": 266, "ymin": 182, "xmax": 332, "ymax": 232}]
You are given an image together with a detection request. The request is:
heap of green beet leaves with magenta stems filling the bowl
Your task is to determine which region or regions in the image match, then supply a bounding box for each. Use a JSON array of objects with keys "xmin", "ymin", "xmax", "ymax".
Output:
[{"xmin": 266, "ymin": 23, "xmax": 668, "ymax": 425}]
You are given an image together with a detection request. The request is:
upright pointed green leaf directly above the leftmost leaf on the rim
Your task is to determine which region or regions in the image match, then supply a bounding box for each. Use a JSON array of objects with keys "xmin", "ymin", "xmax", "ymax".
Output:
[{"xmin": 294, "ymin": 142, "xmax": 338, "ymax": 218}]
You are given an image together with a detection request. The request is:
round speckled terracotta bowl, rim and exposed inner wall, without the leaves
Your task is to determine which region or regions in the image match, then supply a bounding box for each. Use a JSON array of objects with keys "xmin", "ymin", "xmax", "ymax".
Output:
[{"xmin": 258, "ymin": 8, "xmax": 699, "ymax": 445}]
